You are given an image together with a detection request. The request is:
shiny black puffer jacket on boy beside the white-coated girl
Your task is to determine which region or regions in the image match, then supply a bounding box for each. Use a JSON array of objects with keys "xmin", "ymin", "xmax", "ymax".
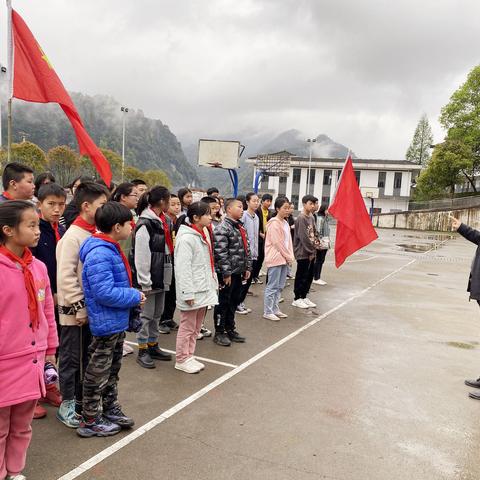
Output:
[{"xmin": 213, "ymin": 217, "xmax": 252, "ymax": 278}]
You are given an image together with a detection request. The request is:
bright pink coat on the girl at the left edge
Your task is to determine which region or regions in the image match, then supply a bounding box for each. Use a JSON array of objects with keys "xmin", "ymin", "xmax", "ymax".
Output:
[{"xmin": 0, "ymin": 254, "xmax": 58, "ymax": 407}]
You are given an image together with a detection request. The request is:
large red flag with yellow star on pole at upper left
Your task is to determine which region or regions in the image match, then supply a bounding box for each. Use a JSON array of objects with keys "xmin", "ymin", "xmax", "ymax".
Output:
[{"xmin": 12, "ymin": 10, "xmax": 112, "ymax": 185}]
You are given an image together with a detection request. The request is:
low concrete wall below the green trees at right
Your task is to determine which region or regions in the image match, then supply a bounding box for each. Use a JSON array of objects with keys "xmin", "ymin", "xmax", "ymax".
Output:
[{"xmin": 373, "ymin": 207, "xmax": 480, "ymax": 232}]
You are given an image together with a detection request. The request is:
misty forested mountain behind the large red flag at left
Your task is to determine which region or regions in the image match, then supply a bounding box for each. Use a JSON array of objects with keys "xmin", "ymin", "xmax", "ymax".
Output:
[{"xmin": 2, "ymin": 93, "xmax": 199, "ymax": 185}]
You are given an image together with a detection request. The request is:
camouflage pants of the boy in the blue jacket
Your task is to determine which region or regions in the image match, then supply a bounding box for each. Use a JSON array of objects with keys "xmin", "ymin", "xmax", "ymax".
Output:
[{"xmin": 83, "ymin": 332, "xmax": 125, "ymax": 418}]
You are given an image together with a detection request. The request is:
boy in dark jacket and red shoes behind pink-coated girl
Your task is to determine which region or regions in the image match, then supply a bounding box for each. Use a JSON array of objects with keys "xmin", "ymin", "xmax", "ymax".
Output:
[{"xmin": 30, "ymin": 183, "xmax": 67, "ymax": 418}]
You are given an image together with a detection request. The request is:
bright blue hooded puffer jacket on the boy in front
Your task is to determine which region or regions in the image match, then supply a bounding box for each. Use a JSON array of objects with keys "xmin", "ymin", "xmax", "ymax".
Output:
[{"xmin": 80, "ymin": 237, "xmax": 140, "ymax": 337}]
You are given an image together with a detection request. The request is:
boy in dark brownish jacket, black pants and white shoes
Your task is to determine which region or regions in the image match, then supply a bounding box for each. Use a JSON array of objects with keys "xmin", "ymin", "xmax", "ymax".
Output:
[{"xmin": 292, "ymin": 195, "xmax": 318, "ymax": 308}]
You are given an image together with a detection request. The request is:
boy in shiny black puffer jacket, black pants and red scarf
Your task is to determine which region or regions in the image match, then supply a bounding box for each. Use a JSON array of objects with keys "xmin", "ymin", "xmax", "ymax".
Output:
[{"xmin": 213, "ymin": 198, "xmax": 252, "ymax": 347}]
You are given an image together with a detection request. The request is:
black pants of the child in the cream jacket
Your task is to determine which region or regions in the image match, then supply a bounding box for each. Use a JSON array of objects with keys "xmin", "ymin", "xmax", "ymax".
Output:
[{"xmin": 58, "ymin": 325, "xmax": 92, "ymax": 413}]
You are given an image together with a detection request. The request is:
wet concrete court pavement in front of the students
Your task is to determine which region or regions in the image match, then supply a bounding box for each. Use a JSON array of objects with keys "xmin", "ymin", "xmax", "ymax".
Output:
[{"xmin": 25, "ymin": 230, "xmax": 480, "ymax": 480}]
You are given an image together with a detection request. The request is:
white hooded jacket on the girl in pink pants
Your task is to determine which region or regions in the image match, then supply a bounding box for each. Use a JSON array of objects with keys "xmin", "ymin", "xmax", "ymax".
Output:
[{"xmin": 175, "ymin": 225, "xmax": 218, "ymax": 310}]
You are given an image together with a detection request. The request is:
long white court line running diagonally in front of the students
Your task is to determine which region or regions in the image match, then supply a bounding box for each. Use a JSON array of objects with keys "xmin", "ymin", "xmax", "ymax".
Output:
[{"xmin": 58, "ymin": 259, "xmax": 417, "ymax": 480}]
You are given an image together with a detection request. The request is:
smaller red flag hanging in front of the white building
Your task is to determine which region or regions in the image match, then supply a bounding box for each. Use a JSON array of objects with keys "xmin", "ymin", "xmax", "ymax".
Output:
[{"xmin": 328, "ymin": 155, "xmax": 378, "ymax": 268}]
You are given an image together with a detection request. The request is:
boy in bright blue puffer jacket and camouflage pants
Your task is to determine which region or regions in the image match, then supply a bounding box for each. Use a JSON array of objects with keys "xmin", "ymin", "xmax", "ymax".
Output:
[{"xmin": 77, "ymin": 202, "xmax": 146, "ymax": 437}]
